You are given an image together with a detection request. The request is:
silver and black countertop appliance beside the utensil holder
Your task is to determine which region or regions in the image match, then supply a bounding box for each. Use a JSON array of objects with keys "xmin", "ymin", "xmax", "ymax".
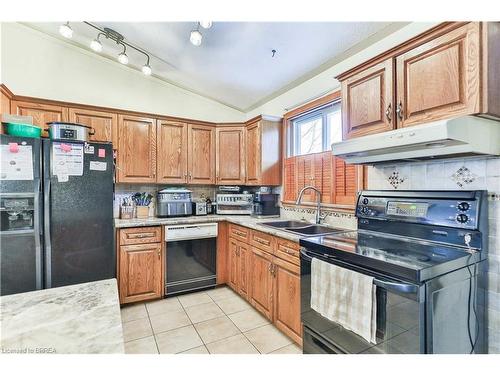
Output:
[{"xmin": 156, "ymin": 188, "xmax": 193, "ymax": 217}]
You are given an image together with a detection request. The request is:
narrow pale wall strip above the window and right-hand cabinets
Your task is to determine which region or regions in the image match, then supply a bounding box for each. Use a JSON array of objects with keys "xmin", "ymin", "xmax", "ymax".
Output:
[{"xmin": 246, "ymin": 22, "xmax": 439, "ymax": 119}]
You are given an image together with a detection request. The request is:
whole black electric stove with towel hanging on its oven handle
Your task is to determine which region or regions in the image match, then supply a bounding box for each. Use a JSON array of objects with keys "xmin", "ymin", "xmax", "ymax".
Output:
[{"xmin": 300, "ymin": 191, "xmax": 488, "ymax": 354}]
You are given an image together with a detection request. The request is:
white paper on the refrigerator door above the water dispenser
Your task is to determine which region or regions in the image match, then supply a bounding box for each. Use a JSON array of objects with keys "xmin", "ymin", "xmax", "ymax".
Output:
[{"xmin": 0, "ymin": 145, "xmax": 33, "ymax": 181}]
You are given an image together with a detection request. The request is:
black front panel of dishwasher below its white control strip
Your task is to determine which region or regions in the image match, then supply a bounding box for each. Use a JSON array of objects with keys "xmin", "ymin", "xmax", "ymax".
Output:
[{"xmin": 165, "ymin": 237, "xmax": 217, "ymax": 296}]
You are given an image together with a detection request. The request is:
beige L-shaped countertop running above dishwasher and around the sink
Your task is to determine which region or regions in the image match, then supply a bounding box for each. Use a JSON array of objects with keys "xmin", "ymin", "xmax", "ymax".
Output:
[{"xmin": 115, "ymin": 215, "xmax": 350, "ymax": 242}]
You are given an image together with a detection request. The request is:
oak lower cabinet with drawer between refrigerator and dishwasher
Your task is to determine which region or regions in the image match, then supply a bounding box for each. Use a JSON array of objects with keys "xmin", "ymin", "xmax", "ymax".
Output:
[{"xmin": 117, "ymin": 227, "xmax": 165, "ymax": 304}]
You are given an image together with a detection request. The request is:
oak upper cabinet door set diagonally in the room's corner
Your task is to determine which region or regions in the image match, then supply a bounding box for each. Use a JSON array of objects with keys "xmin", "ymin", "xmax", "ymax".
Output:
[{"xmin": 215, "ymin": 126, "xmax": 245, "ymax": 185}]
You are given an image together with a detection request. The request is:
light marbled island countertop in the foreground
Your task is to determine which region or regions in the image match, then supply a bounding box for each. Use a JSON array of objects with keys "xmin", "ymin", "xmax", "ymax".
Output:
[{"xmin": 0, "ymin": 279, "xmax": 124, "ymax": 354}]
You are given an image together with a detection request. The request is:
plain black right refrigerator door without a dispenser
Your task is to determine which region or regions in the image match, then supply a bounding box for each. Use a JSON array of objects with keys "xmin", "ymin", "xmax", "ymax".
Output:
[{"xmin": 43, "ymin": 140, "xmax": 115, "ymax": 288}]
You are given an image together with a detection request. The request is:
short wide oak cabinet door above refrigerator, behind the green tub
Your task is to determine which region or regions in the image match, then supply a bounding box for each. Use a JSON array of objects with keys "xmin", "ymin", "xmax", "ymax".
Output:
[{"xmin": 10, "ymin": 100, "xmax": 68, "ymax": 135}]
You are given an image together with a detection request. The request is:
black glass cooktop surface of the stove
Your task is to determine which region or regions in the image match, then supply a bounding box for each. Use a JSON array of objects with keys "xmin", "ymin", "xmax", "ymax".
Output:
[{"xmin": 300, "ymin": 231, "xmax": 480, "ymax": 282}]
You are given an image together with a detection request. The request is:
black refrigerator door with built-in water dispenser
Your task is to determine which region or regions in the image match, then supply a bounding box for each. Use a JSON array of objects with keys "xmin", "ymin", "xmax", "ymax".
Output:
[{"xmin": 0, "ymin": 135, "xmax": 43, "ymax": 295}]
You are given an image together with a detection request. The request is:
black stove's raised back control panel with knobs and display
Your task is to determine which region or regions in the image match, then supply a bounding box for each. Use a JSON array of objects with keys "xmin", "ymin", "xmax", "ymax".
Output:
[{"xmin": 356, "ymin": 191, "xmax": 481, "ymax": 229}]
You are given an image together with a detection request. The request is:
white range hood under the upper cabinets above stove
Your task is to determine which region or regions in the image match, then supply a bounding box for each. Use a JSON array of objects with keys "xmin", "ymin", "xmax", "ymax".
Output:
[{"xmin": 332, "ymin": 116, "xmax": 500, "ymax": 164}]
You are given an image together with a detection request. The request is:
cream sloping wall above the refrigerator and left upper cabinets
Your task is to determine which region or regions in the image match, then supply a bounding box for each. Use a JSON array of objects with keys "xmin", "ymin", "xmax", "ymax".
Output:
[{"xmin": 0, "ymin": 22, "xmax": 245, "ymax": 122}]
